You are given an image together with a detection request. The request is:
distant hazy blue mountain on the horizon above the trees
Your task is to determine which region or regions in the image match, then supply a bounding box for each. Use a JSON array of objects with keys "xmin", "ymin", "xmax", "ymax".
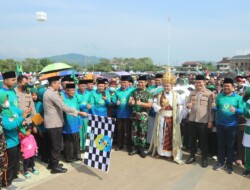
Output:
[{"xmin": 47, "ymin": 53, "xmax": 102, "ymax": 66}]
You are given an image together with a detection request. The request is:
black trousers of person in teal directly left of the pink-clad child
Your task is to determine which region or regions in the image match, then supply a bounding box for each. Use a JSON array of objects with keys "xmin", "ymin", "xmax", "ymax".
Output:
[{"xmin": 2, "ymin": 145, "xmax": 20, "ymax": 187}]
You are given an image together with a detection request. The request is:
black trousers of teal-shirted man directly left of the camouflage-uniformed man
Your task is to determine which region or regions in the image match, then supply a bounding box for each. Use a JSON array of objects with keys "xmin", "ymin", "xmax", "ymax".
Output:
[{"xmin": 117, "ymin": 118, "xmax": 132, "ymax": 151}]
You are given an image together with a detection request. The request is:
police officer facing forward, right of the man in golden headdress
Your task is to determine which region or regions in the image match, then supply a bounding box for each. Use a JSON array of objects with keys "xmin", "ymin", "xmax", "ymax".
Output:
[{"xmin": 186, "ymin": 75, "xmax": 215, "ymax": 168}]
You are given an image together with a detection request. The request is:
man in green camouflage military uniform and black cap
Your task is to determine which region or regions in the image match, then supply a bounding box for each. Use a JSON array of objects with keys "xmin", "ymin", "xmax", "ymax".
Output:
[{"xmin": 129, "ymin": 76, "xmax": 153, "ymax": 158}]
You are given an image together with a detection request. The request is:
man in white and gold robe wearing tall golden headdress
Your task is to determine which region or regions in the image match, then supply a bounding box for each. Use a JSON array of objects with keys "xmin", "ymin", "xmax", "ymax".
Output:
[{"xmin": 148, "ymin": 67, "xmax": 183, "ymax": 164}]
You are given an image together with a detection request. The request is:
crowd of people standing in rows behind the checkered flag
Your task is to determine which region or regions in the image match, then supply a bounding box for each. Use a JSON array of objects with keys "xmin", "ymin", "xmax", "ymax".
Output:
[{"xmin": 0, "ymin": 70, "xmax": 250, "ymax": 189}]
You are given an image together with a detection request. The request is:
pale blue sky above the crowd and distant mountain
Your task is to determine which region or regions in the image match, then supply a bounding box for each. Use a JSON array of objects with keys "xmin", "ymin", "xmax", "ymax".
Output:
[{"xmin": 0, "ymin": 0, "xmax": 250, "ymax": 65}]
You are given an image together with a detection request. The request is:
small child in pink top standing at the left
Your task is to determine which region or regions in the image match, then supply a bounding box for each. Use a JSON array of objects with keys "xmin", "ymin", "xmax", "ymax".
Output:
[{"xmin": 19, "ymin": 126, "xmax": 38, "ymax": 179}]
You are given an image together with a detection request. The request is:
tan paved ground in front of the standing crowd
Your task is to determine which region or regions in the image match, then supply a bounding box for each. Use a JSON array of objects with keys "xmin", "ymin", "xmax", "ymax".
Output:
[{"xmin": 12, "ymin": 150, "xmax": 250, "ymax": 190}]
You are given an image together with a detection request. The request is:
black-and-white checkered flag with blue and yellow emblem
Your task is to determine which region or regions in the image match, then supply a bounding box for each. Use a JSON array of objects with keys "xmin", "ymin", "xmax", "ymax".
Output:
[{"xmin": 83, "ymin": 115, "xmax": 116, "ymax": 172}]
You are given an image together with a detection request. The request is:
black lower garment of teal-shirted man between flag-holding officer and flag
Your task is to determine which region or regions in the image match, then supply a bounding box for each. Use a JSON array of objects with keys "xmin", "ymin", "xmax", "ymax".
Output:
[{"xmin": 63, "ymin": 133, "xmax": 80, "ymax": 161}]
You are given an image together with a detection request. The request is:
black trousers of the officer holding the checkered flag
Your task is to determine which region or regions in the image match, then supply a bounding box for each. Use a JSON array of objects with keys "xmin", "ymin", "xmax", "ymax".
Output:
[{"xmin": 47, "ymin": 127, "xmax": 62, "ymax": 169}]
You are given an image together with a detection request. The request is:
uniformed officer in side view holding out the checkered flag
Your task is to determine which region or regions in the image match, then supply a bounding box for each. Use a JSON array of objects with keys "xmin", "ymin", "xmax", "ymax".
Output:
[{"xmin": 43, "ymin": 77, "xmax": 87, "ymax": 174}]
